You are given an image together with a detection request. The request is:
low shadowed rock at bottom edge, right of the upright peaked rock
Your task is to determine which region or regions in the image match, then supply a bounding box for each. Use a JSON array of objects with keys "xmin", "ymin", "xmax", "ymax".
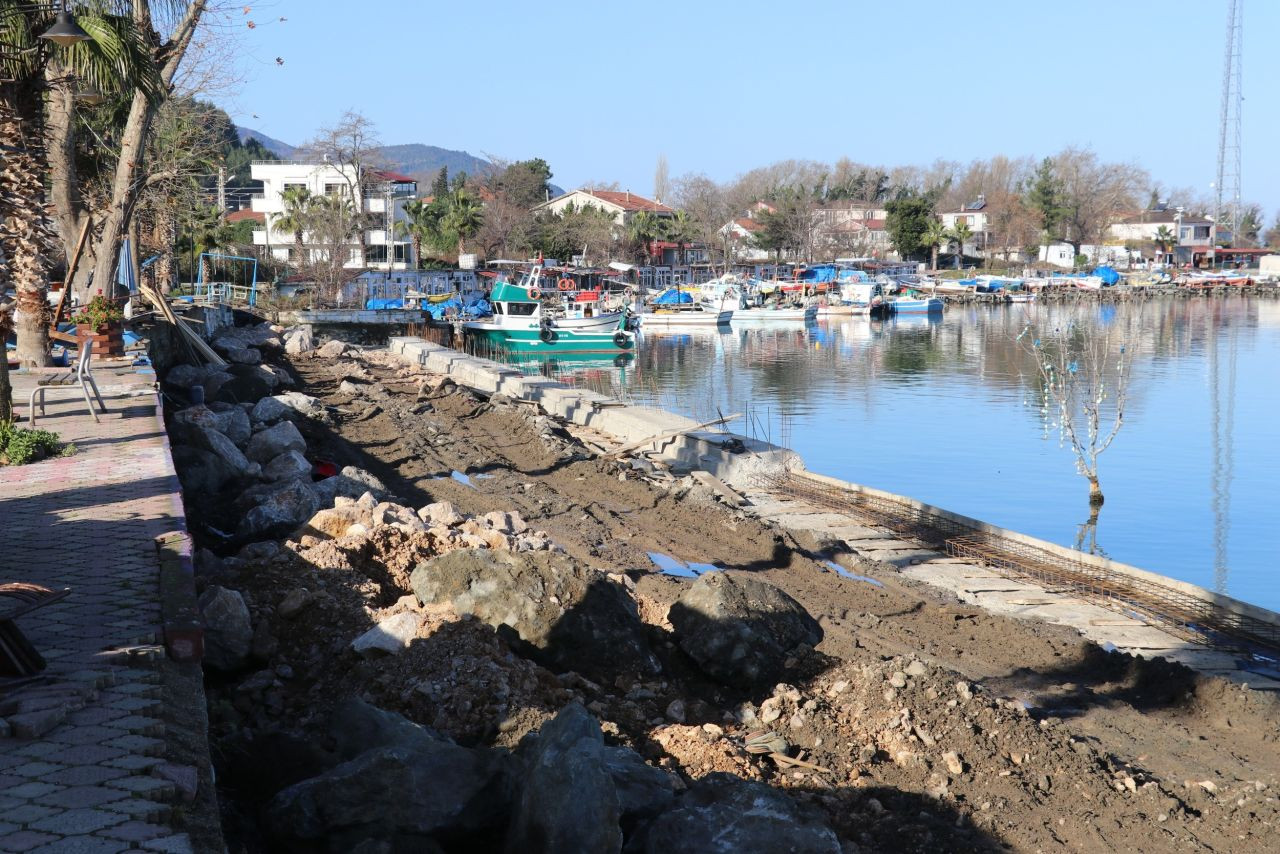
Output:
[{"xmin": 626, "ymin": 773, "xmax": 841, "ymax": 854}]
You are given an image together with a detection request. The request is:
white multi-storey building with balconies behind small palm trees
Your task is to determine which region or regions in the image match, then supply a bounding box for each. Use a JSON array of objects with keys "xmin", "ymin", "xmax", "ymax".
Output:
[{"xmin": 250, "ymin": 160, "xmax": 417, "ymax": 270}]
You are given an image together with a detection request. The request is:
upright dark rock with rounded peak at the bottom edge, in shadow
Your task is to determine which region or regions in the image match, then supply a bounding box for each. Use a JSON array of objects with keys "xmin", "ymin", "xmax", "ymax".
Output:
[{"xmin": 507, "ymin": 703, "xmax": 622, "ymax": 854}]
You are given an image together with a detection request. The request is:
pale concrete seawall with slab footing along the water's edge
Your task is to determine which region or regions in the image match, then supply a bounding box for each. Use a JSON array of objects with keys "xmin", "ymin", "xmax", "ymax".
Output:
[{"xmin": 389, "ymin": 337, "xmax": 1280, "ymax": 690}]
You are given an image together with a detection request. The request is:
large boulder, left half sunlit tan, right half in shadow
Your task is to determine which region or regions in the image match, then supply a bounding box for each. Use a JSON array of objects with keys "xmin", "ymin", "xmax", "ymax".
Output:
[{"xmin": 410, "ymin": 549, "xmax": 658, "ymax": 681}]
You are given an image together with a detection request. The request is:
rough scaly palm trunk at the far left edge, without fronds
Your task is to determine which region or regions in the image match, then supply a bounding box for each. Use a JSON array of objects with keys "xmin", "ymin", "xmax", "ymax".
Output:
[{"xmin": 0, "ymin": 90, "xmax": 55, "ymax": 367}]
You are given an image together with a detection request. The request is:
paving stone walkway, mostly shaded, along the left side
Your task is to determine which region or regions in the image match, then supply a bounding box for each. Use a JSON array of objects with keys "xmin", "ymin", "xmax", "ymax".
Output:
[{"xmin": 0, "ymin": 366, "xmax": 196, "ymax": 854}]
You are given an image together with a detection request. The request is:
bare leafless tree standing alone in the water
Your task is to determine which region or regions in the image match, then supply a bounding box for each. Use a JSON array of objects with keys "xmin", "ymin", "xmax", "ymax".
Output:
[{"xmin": 1018, "ymin": 311, "xmax": 1130, "ymax": 524}]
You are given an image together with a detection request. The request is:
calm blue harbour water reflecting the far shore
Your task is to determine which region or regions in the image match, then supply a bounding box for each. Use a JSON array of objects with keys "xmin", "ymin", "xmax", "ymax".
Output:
[{"xmin": 499, "ymin": 297, "xmax": 1280, "ymax": 609}]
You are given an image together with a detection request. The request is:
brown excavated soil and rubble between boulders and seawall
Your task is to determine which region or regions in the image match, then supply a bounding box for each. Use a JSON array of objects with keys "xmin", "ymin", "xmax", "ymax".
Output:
[{"xmin": 202, "ymin": 353, "xmax": 1280, "ymax": 851}]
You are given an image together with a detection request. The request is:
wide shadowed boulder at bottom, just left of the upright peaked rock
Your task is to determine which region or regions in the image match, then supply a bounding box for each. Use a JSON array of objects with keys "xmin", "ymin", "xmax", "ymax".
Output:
[{"xmin": 268, "ymin": 704, "xmax": 509, "ymax": 851}]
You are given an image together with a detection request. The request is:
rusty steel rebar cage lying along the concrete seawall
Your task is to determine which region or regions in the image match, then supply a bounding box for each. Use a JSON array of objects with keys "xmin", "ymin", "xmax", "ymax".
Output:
[{"xmin": 762, "ymin": 472, "xmax": 1280, "ymax": 650}]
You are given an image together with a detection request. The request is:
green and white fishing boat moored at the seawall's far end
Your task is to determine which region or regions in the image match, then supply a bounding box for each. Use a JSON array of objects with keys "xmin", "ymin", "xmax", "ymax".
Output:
[{"xmin": 462, "ymin": 266, "xmax": 636, "ymax": 353}]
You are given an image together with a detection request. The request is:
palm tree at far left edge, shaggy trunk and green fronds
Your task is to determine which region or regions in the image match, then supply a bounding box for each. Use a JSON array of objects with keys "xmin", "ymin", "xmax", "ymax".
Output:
[{"xmin": 0, "ymin": 0, "xmax": 164, "ymax": 365}]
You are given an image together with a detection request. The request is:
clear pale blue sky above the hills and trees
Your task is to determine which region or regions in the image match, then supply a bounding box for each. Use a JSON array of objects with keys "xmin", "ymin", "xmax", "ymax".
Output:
[{"xmin": 232, "ymin": 0, "xmax": 1280, "ymax": 217}]
